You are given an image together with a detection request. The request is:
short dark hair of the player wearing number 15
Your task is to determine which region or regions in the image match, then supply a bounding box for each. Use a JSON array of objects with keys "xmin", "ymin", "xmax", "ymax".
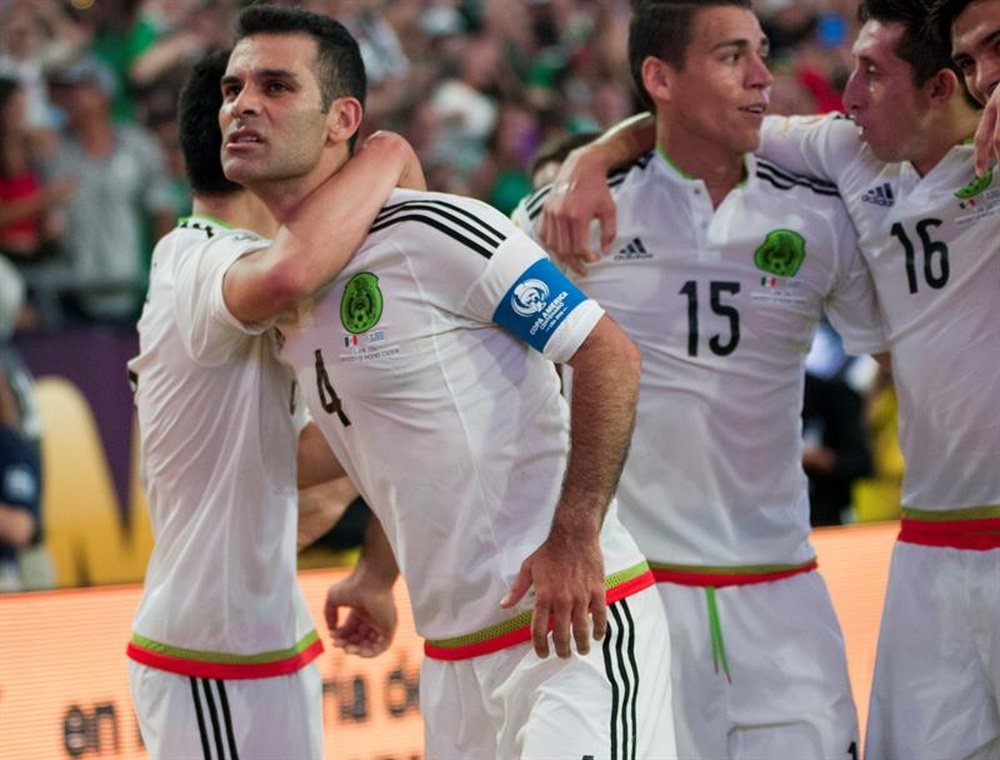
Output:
[{"xmin": 628, "ymin": 0, "xmax": 751, "ymax": 109}]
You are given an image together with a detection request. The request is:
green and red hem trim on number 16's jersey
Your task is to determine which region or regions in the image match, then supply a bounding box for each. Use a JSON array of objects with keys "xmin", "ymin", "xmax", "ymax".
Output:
[{"xmin": 897, "ymin": 506, "xmax": 1000, "ymax": 551}]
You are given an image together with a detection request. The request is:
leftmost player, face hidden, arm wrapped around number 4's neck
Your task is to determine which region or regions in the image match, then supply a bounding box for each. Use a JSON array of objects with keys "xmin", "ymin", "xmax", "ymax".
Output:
[{"xmin": 128, "ymin": 54, "xmax": 422, "ymax": 758}]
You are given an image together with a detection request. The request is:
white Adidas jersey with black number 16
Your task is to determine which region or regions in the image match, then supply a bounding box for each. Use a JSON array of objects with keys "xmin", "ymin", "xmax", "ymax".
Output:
[{"xmin": 762, "ymin": 116, "xmax": 1000, "ymax": 510}]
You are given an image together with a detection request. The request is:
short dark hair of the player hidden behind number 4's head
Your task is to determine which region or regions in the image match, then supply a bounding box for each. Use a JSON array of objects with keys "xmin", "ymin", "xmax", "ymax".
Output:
[{"xmin": 177, "ymin": 50, "xmax": 243, "ymax": 195}]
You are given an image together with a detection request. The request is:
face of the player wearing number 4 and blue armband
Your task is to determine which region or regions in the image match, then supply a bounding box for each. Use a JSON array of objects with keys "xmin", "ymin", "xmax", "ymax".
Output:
[{"xmin": 219, "ymin": 34, "xmax": 329, "ymax": 189}]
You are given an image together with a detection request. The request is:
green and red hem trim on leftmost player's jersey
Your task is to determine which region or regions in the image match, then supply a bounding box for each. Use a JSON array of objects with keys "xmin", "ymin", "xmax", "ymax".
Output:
[{"xmin": 125, "ymin": 630, "xmax": 323, "ymax": 679}]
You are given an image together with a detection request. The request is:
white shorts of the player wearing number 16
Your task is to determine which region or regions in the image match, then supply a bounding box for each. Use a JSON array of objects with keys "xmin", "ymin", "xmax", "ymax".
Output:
[{"xmin": 865, "ymin": 543, "xmax": 1000, "ymax": 760}]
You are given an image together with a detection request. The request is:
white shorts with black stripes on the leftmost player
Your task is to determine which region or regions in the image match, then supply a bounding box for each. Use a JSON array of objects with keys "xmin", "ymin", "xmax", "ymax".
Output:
[{"xmin": 128, "ymin": 660, "xmax": 324, "ymax": 760}]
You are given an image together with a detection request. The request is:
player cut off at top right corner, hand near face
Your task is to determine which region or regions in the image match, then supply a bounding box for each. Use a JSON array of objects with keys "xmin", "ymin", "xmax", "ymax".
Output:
[{"xmin": 931, "ymin": 0, "xmax": 1000, "ymax": 176}]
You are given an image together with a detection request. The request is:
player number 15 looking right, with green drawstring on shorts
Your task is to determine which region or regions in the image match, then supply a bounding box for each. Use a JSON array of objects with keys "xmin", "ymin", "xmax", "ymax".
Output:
[{"xmin": 515, "ymin": 0, "xmax": 882, "ymax": 758}]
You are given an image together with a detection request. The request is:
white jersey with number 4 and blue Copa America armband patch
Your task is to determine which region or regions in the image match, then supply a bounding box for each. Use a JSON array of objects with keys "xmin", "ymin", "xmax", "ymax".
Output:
[{"xmin": 281, "ymin": 190, "xmax": 643, "ymax": 640}]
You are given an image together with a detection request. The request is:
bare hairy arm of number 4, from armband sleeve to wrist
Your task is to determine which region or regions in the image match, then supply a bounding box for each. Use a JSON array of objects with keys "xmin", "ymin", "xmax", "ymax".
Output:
[{"xmin": 553, "ymin": 317, "xmax": 641, "ymax": 535}]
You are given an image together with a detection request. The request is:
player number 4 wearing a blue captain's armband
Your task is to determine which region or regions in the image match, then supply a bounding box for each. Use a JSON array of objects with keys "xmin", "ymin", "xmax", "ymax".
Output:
[{"xmin": 221, "ymin": 6, "xmax": 675, "ymax": 759}]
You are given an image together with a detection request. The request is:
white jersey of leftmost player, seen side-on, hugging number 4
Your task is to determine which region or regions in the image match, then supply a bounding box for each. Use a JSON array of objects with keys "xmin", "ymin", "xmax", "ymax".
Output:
[{"xmin": 129, "ymin": 217, "xmax": 322, "ymax": 678}]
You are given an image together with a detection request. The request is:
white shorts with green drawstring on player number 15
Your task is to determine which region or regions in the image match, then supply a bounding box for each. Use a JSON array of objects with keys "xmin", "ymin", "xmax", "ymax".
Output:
[{"xmin": 657, "ymin": 572, "xmax": 859, "ymax": 760}]
